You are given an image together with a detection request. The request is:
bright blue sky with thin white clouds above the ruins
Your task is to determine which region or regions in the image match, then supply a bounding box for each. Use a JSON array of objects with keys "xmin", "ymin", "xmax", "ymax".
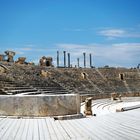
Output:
[{"xmin": 0, "ymin": 0, "xmax": 140, "ymax": 67}]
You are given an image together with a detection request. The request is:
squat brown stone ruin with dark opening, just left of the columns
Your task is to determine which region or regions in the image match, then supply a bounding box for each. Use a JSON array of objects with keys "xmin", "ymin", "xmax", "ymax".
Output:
[{"xmin": 39, "ymin": 56, "xmax": 53, "ymax": 67}]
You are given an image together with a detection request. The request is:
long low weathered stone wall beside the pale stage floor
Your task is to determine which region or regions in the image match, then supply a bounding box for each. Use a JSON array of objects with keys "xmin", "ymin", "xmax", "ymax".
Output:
[{"xmin": 0, "ymin": 94, "xmax": 80, "ymax": 117}]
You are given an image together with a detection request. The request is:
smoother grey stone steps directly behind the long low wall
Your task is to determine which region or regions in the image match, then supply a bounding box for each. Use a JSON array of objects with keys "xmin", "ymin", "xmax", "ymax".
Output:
[{"xmin": 0, "ymin": 75, "xmax": 70, "ymax": 95}]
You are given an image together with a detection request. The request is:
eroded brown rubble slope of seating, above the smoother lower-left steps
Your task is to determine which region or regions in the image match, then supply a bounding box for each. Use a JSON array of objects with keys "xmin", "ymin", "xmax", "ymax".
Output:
[{"xmin": 0, "ymin": 65, "xmax": 140, "ymax": 96}]
